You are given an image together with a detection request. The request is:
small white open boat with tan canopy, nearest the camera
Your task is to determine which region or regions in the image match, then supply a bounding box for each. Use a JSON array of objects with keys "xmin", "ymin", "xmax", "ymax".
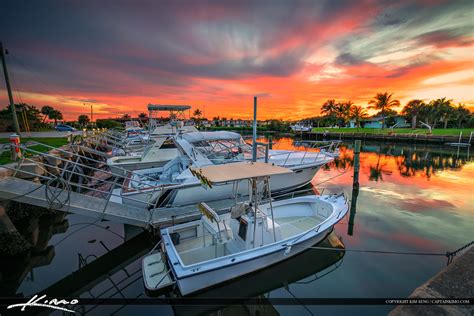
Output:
[{"xmin": 142, "ymin": 162, "xmax": 349, "ymax": 295}]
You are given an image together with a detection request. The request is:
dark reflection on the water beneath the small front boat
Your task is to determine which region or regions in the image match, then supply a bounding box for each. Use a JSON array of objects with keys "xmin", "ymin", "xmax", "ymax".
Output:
[{"xmin": 167, "ymin": 231, "xmax": 345, "ymax": 315}]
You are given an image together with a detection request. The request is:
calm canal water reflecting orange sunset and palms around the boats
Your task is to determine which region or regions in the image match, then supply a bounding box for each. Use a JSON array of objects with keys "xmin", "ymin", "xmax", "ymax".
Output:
[{"xmin": 0, "ymin": 138, "xmax": 474, "ymax": 315}]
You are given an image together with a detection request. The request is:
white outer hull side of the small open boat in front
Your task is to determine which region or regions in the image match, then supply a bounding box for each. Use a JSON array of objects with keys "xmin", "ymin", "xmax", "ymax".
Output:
[{"xmin": 175, "ymin": 226, "xmax": 333, "ymax": 295}]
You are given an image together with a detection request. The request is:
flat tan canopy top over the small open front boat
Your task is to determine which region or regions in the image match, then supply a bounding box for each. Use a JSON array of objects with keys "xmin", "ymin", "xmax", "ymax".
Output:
[{"xmin": 191, "ymin": 162, "xmax": 293, "ymax": 184}]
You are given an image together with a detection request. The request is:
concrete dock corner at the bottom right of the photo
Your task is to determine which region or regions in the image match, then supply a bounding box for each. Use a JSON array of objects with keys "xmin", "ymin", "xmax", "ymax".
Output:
[{"xmin": 389, "ymin": 246, "xmax": 474, "ymax": 316}]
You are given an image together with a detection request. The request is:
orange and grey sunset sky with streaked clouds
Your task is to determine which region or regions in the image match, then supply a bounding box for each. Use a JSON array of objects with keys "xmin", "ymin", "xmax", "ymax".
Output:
[{"xmin": 0, "ymin": 0, "xmax": 474, "ymax": 120}]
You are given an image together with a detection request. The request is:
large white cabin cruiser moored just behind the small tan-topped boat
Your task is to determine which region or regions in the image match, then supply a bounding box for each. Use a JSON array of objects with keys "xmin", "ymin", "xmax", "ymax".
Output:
[{"xmin": 118, "ymin": 131, "xmax": 334, "ymax": 207}]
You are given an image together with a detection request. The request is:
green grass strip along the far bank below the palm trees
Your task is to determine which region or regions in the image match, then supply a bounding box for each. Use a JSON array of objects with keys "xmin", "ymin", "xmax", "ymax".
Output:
[{"xmin": 312, "ymin": 127, "xmax": 474, "ymax": 136}]
